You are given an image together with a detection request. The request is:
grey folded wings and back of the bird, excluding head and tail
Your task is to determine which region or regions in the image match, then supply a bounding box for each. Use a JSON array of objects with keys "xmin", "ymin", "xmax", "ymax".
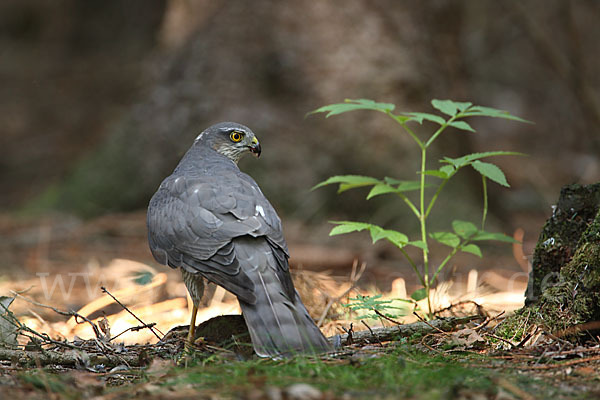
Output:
[{"xmin": 147, "ymin": 170, "xmax": 293, "ymax": 304}]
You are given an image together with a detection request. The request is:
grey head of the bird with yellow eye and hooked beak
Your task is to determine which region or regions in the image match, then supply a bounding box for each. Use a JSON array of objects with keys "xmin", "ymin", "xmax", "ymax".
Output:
[{"xmin": 195, "ymin": 122, "xmax": 260, "ymax": 163}]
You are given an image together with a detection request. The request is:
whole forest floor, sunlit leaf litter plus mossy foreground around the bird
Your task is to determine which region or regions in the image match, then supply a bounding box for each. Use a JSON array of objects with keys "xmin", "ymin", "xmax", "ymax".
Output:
[{"xmin": 0, "ymin": 213, "xmax": 600, "ymax": 399}]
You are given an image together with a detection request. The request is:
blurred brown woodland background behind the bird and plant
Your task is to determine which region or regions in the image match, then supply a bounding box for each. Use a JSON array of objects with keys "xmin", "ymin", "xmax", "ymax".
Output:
[{"xmin": 0, "ymin": 0, "xmax": 600, "ymax": 342}]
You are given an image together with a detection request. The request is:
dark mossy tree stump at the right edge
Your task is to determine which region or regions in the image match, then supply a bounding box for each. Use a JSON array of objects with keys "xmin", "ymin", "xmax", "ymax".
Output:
[{"xmin": 507, "ymin": 183, "xmax": 600, "ymax": 336}]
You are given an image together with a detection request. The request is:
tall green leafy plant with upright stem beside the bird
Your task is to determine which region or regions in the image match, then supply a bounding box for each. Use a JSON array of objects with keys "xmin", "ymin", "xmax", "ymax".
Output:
[{"xmin": 310, "ymin": 99, "xmax": 528, "ymax": 317}]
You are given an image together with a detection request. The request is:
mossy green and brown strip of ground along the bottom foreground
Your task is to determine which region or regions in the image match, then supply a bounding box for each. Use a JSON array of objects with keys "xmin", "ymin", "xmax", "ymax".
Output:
[{"xmin": 0, "ymin": 328, "xmax": 600, "ymax": 400}]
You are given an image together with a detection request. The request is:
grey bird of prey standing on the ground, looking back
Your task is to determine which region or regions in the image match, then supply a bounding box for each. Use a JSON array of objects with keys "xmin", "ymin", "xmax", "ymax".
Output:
[{"xmin": 147, "ymin": 122, "xmax": 331, "ymax": 357}]
